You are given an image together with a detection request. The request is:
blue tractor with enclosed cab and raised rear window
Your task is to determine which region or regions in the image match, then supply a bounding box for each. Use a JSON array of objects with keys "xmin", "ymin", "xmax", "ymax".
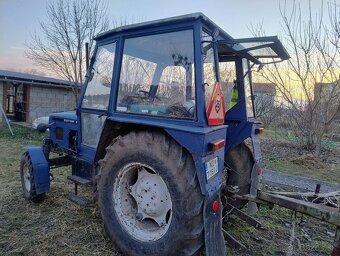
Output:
[{"xmin": 21, "ymin": 13, "xmax": 289, "ymax": 255}]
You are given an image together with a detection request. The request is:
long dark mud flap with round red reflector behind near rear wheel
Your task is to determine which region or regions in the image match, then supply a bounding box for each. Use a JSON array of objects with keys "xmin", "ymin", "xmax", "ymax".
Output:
[{"xmin": 203, "ymin": 193, "xmax": 226, "ymax": 256}]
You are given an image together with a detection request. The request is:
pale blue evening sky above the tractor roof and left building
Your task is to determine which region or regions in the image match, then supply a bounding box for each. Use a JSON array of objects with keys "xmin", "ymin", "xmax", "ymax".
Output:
[{"xmin": 0, "ymin": 0, "xmax": 332, "ymax": 78}]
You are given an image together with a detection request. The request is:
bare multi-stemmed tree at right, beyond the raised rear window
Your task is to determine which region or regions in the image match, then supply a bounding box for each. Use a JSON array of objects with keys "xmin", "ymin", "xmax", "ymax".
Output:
[{"xmin": 252, "ymin": 1, "xmax": 340, "ymax": 155}]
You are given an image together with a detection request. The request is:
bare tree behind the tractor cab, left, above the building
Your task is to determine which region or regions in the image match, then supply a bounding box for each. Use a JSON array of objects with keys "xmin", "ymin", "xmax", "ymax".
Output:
[{"xmin": 26, "ymin": 0, "xmax": 108, "ymax": 101}]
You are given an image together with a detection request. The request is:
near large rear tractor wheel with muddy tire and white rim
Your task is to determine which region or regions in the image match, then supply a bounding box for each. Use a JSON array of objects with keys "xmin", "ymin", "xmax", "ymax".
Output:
[{"xmin": 98, "ymin": 132, "xmax": 204, "ymax": 255}]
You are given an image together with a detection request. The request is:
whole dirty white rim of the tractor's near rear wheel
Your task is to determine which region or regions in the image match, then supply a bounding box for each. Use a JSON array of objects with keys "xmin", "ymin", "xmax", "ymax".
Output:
[{"xmin": 113, "ymin": 163, "xmax": 172, "ymax": 242}]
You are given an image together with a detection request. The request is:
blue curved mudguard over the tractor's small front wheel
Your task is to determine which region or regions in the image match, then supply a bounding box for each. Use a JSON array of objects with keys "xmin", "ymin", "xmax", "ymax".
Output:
[{"xmin": 26, "ymin": 147, "xmax": 50, "ymax": 194}]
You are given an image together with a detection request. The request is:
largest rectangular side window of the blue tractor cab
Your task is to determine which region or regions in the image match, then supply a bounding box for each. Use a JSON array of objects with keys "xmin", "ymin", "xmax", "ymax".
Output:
[{"xmin": 116, "ymin": 30, "xmax": 196, "ymax": 119}]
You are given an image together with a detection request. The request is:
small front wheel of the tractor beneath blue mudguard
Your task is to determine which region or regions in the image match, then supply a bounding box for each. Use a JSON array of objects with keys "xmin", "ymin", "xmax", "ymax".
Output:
[{"xmin": 20, "ymin": 152, "xmax": 45, "ymax": 202}]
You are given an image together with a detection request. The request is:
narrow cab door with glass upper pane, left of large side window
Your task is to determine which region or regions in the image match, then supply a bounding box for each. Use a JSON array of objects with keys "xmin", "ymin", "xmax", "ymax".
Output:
[{"xmin": 78, "ymin": 42, "xmax": 117, "ymax": 161}]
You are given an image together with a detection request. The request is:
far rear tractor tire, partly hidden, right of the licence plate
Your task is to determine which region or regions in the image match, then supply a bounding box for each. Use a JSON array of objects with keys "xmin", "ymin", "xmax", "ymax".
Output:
[{"xmin": 224, "ymin": 142, "xmax": 255, "ymax": 209}]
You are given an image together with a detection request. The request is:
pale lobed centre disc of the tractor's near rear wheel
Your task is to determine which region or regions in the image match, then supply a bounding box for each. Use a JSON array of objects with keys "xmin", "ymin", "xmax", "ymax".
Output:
[{"xmin": 130, "ymin": 167, "xmax": 171, "ymax": 227}]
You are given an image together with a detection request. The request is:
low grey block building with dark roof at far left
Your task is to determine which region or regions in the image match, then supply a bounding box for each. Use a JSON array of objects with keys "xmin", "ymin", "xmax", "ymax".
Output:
[{"xmin": 0, "ymin": 70, "xmax": 76, "ymax": 123}]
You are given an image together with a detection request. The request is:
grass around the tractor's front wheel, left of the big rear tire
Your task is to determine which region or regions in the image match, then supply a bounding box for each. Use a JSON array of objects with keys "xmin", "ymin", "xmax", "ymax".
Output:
[{"xmin": 0, "ymin": 127, "xmax": 118, "ymax": 255}]
